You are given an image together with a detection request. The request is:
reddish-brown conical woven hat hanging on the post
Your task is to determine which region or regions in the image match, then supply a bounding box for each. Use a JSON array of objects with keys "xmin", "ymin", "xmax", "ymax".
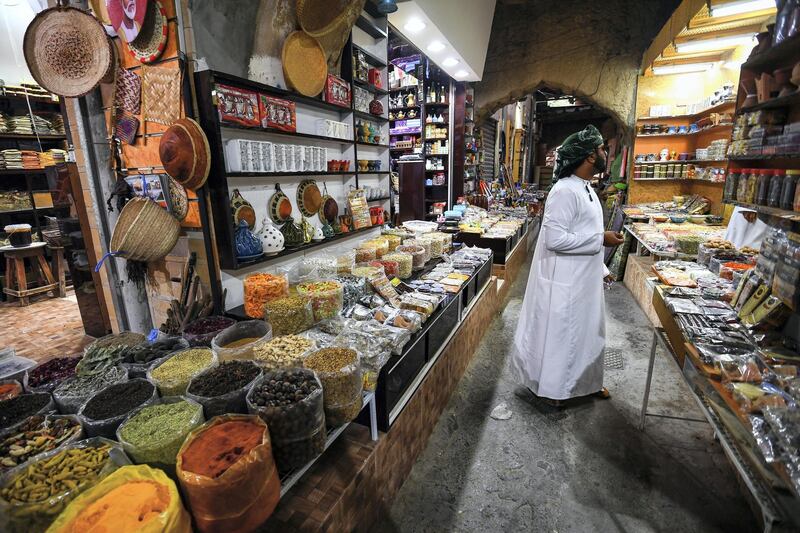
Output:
[{"xmin": 158, "ymin": 118, "xmax": 211, "ymax": 190}]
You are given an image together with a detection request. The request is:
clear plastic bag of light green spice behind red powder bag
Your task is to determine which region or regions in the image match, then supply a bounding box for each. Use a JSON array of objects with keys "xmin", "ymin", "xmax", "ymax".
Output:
[{"xmin": 117, "ymin": 396, "xmax": 205, "ymax": 470}]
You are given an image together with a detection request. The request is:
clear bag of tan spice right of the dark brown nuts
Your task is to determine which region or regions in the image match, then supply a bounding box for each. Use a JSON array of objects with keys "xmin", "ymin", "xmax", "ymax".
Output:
[{"xmin": 303, "ymin": 347, "xmax": 363, "ymax": 427}]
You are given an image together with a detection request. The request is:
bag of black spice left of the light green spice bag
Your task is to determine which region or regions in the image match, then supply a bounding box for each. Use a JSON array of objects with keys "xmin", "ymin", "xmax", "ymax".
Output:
[{"xmin": 78, "ymin": 378, "xmax": 158, "ymax": 439}]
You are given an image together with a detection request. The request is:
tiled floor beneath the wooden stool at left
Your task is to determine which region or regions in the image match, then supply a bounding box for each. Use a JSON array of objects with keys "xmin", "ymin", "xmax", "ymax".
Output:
[{"xmin": 0, "ymin": 291, "xmax": 92, "ymax": 362}]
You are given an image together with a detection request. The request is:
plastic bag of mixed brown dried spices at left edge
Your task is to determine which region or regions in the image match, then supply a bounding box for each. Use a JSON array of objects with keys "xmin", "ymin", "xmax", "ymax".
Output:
[{"xmin": 0, "ymin": 415, "xmax": 83, "ymax": 473}]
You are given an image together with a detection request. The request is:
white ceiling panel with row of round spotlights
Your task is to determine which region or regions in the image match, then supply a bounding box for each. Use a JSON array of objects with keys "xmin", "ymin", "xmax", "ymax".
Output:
[{"xmin": 389, "ymin": 0, "xmax": 495, "ymax": 81}]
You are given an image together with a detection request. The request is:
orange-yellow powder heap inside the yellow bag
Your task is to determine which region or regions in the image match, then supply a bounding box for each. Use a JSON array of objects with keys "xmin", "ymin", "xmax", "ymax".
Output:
[{"xmin": 62, "ymin": 480, "xmax": 170, "ymax": 533}]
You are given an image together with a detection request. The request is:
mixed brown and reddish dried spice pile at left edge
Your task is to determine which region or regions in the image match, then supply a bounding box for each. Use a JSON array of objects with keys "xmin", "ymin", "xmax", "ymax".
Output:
[{"xmin": 0, "ymin": 415, "xmax": 81, "ymax": 471}]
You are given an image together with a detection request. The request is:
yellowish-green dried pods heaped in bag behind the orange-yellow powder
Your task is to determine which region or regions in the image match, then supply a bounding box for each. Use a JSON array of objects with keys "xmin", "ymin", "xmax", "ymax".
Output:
[{"xmin": 0, "ymin": 444, "xmax": 111, "ymax": 505}]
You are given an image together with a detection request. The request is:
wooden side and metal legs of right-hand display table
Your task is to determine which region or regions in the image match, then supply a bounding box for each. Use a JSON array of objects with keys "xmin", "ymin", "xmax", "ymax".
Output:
[{"xmin": 639, "ymin": 286, "xmax": 800, "ymax": 531}]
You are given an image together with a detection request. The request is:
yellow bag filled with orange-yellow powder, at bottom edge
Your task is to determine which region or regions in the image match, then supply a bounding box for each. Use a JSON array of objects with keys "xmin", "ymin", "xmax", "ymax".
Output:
[{"xmin": 48, "ymin": 465, "xmax": 192, "ymax": 533}]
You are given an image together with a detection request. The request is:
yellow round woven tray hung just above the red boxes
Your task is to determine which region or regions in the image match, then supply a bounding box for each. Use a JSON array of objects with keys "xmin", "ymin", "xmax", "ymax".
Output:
[{"xmin": 281, "ymin": 31, "xmax": 328, "ymax": 96}]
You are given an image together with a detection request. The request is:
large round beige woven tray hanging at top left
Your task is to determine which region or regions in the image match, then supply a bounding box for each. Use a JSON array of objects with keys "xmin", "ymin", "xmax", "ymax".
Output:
[{"xmin": 23, "ymin": 7, "xmax": 114, "ymax": 98}]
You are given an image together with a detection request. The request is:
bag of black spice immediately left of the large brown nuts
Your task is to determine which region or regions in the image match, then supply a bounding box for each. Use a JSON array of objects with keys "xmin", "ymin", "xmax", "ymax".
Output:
[{"xmin": 186, "ymin": 361, "xmax": 263, "ymax": 418}]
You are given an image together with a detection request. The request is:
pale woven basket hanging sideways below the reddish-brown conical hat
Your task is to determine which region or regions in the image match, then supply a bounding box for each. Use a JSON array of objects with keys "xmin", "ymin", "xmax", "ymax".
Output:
[{"xmin": 109, "ymin": 196, "xmax": 181, "ymax": 263}]
